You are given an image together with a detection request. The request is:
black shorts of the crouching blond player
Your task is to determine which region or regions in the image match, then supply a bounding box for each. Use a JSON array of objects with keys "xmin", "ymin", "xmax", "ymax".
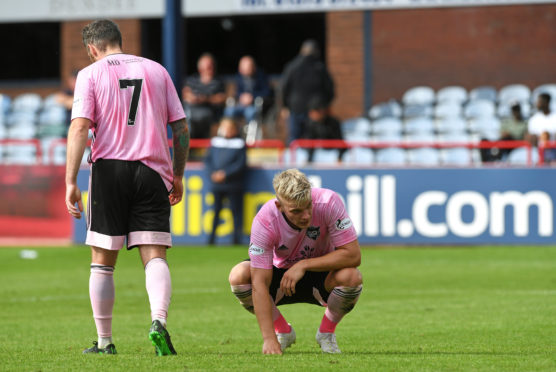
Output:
[{"xmin": 269, "ymin": 266, "xmax": 330, "ymax": 306}]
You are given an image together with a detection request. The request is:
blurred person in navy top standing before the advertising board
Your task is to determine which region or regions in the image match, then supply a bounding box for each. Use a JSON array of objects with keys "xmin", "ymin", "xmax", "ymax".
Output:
[{"xmin": 205, "ymin": 117, "xmax": 247, "ymax": 245}]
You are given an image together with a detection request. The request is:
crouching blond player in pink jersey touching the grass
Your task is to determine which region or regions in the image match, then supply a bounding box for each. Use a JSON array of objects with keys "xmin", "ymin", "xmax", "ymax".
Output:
[{"xmin": 229, "ymin": 169, "xmax": 363, "ymax": 354}]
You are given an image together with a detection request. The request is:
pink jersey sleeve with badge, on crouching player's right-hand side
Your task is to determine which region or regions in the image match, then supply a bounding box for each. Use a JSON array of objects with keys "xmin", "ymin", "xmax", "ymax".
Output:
[{"xmin": 326, "ymin": 193, "xmax": 357, "ymax": 247}]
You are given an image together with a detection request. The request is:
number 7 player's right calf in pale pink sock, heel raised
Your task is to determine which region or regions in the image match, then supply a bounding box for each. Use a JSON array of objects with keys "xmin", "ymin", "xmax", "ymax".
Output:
[{"xmin": 145, "ymin": 257, "xmax": 172, "ymax": 327}]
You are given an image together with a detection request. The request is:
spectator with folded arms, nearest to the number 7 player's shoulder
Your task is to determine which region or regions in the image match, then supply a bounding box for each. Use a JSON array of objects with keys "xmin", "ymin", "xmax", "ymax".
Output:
[{"xmin": 182, "ymin": 53, "xmax": 226, "ymax": 138}]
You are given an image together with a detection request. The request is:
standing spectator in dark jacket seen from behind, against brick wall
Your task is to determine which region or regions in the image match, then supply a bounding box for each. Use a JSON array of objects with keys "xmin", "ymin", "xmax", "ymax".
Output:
[{"xmin": 281, "ymin": 40, "xmax": 334, "ymax": 143}]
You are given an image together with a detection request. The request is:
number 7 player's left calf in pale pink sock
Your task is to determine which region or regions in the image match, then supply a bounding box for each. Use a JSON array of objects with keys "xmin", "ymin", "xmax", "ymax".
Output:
[{"xmin": 89, "ymin": 263, "xmax": 115, "ymax": 348}]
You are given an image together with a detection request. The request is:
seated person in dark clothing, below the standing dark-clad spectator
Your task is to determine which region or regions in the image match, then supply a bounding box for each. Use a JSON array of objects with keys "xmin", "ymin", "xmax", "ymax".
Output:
[{"xmin": 303, "ymin": 97, "xmax": 347, "ymax": 162}]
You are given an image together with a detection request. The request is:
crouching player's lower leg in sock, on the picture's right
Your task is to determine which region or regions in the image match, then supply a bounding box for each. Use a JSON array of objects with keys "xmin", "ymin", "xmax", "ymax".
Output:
[{"xmin": 319, "ymin": 285, "xmax": 363, "ymax": 333}]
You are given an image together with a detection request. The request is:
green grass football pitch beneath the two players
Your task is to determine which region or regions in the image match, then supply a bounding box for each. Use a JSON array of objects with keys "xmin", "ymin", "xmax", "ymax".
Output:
[{"xmin": 0, "ymin": 247, "xmax": 556, "ymax": 371}]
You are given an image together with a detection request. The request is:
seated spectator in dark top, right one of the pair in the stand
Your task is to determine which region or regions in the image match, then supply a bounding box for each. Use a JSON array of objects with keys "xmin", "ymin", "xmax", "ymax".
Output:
[{"xmin": 224, "ymin": 56, "xmax": 272, "ymax": 123}]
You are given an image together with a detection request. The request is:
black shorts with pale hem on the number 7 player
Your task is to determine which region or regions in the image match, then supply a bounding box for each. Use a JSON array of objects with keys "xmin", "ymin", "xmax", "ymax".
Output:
[{"xmin": 86, "ymin": 159, "xmax": 172, "ymax": 250}]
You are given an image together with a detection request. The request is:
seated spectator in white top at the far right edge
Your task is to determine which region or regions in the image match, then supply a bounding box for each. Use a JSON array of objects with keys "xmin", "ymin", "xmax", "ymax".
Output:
[{"xmin": 528, "ymin": 93, "xmax": 556, "ymax": 163}]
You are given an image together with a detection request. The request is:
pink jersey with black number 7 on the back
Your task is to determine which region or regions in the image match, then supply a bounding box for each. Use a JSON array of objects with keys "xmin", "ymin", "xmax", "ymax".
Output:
[{"xmin": 71, "ymin": 53, "xmax": 185, "ymax": 189}]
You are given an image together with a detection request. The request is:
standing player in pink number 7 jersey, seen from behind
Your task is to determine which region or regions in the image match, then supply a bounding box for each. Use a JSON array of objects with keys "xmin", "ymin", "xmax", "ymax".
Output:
[{"xmin": 66, "ymin": 20, "xmax": 189, "ymax": 355}]
